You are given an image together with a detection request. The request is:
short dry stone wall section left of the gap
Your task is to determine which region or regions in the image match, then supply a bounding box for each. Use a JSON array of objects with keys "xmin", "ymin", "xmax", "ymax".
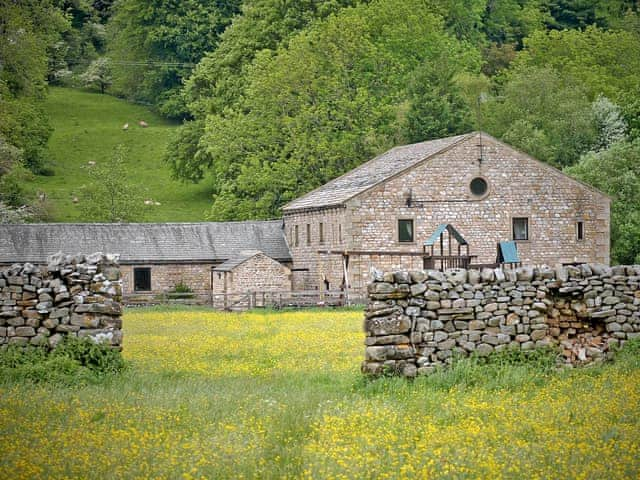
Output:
[{"xmin": 0, "ymin": 253, "xmax": 122, "ymax": 348}]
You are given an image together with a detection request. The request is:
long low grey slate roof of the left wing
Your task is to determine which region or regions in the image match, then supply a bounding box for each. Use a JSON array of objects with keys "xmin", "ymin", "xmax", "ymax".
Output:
[{"xmin": 0, "ymin": 220, "xmax": 291, "ymax": 264}]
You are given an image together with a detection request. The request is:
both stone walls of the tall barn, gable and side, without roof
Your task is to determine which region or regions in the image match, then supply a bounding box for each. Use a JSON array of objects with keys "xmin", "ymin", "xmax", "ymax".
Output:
[{"xmin": 284, "ymin": 136, "xmax": 610, "ymax": 292}]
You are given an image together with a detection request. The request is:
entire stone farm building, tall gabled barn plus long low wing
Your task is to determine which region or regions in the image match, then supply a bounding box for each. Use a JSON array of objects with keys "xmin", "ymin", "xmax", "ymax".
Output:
[{"xmin": 0, "ymin": 132, "xmax": 611, "ymax": 296}]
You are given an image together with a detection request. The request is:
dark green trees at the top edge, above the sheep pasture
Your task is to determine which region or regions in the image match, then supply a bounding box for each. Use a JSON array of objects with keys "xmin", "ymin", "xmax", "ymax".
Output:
[{"xmin": 108, "ymin": 0, "xmax": 240, "ymax": 117}]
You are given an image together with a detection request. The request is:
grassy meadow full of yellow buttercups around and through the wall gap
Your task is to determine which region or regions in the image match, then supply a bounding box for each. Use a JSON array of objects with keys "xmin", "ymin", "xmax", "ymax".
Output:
[{"xmin": 0, "ymin": 309, "xmax": 640, "ymax": 480}]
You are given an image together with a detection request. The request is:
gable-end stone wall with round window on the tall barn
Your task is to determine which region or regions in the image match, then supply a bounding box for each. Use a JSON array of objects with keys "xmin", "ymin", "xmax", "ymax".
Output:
[{"xmin": 346, "ymin": 137, "xmax": 610, "ymax": 270}]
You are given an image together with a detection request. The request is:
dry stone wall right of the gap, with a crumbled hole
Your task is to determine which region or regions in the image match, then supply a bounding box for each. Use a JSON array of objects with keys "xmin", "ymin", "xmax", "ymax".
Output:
[{"xmin": 362, "ymin": 264, "xmax": 640, "ymax": 377}]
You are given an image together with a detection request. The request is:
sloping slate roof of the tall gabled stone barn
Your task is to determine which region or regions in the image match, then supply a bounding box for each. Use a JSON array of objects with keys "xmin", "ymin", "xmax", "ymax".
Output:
[{"xmin": 282, "ymin": 132, "xmax": 475, "ymax": 212}]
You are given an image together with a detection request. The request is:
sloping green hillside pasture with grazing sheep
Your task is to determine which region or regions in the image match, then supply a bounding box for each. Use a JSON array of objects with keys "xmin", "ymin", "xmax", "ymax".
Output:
[{"xmin": 31, "ymin": 88, "xmax": 211, "ymax": 222}]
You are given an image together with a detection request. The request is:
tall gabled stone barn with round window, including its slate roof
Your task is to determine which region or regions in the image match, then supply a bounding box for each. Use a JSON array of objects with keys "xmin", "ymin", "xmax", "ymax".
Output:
[{"xmin": 283, "ymin": 132, "xmax": 610, "ymax": 291}]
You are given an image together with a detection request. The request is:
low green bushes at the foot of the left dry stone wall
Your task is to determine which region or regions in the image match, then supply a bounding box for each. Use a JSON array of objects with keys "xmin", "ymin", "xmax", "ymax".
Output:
[{"xmin": 0, "ymin": 337, "xmax": 126, "ymax": 386}]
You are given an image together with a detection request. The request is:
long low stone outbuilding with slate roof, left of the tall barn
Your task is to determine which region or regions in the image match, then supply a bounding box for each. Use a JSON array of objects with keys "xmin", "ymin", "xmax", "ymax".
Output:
[{"xmin": 0, "ymin": 220, "xmax": 291, "ymax": 300}]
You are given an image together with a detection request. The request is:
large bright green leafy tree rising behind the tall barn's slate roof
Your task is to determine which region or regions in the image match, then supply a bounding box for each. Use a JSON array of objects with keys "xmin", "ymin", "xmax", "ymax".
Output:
[{"xmin": 170, "ymin": 1, "xmax": 480, "ymax": 219}]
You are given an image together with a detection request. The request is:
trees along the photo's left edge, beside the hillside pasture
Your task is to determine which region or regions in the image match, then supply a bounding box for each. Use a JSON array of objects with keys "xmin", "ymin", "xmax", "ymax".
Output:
[{"xmin": 0, "ymin": 0, "xmax": 69, "ymax": 223}]
